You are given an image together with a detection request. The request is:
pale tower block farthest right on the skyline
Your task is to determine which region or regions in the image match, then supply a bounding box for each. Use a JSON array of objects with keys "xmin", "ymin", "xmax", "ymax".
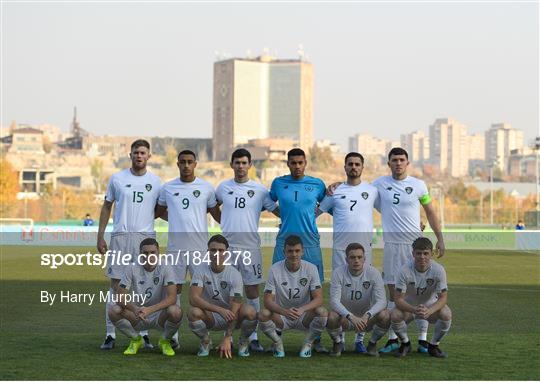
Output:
[{"xmin": 486, "ymin": 123, "xmax": 523, "ymax": 173}]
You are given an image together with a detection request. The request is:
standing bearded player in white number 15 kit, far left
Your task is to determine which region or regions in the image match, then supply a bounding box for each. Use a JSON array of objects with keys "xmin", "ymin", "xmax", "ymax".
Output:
[{"xmin": 97, "ymin": 139, "xmax": 161, "ymax": 350}]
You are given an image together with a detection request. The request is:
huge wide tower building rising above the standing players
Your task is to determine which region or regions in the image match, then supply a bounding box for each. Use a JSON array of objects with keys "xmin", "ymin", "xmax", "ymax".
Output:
[{"xmin": 212, "ymin": 55, "xmax": 313, "ymax": 160}]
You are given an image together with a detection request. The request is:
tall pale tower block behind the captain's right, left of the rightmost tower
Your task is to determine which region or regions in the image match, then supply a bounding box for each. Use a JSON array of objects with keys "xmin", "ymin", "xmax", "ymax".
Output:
[{"xmin": 429, "ymin": 118, "xmax": 469, "ymax": 177}]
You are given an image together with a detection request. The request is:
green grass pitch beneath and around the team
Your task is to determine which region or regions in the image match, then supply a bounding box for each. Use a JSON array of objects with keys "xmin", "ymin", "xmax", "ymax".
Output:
[{"xmin": 0, "ymin": 246, "xmax": 540, "ymax": 380}]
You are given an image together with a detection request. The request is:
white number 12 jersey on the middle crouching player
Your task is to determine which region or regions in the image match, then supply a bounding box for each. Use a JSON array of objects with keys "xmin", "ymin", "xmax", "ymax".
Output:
[{"xmin": 264, "ymin": 260, "xmax": 321, "ymax": 309}]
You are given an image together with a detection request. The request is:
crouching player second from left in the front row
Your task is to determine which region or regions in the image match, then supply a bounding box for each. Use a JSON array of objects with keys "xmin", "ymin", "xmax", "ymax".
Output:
[{"xmin": 188, "ymin": 235, "xmax": 257, "ymax": 358}]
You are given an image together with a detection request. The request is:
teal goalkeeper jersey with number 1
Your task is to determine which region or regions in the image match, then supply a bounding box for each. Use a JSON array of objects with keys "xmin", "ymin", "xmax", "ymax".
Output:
[{"xmin": 270, "ymin": 175, "xmax": 326, "ymax": 247}]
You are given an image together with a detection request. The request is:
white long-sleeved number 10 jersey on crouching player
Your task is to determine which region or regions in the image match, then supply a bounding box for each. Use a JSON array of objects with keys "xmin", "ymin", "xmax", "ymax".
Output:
[{"xmin": 330, "ymin": 264, "xmax": 386, "ymax": 317}]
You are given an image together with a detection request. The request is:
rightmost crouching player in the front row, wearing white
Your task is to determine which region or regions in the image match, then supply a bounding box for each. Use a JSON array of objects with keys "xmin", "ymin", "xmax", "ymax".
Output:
[{"xmin": 391, "ymin": 237, "xmax": 452, "ymax": 358}]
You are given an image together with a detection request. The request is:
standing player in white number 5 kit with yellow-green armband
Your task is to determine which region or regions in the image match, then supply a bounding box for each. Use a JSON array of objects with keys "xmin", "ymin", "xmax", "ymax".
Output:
[{"xmin": 373, "ymin": 147, "xmax": 445, "ymax": 353}]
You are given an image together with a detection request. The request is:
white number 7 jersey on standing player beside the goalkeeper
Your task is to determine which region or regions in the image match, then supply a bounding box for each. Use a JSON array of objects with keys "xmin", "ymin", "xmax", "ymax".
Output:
[{"xmin": 319, "ymin": 182, "xmax": 379, "ymax": 250}]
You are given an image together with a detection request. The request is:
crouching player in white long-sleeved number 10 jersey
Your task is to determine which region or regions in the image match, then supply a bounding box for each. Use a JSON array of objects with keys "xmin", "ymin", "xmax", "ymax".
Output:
[{"xmin": 326, "ymin": 243, "xmax": 390, "ymax": 357}]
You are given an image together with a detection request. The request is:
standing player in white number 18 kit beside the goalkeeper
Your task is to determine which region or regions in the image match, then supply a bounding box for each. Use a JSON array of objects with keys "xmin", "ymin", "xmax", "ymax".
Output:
[{"xmin": 216, "ymin": 149, "xmax": 279, "ymax": 352}]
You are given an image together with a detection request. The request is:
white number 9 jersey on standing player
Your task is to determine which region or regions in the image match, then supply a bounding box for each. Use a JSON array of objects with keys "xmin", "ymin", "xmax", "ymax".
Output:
[{"xmin": 158, "ymin": 178, "xmax": 217, "ymax": 252}]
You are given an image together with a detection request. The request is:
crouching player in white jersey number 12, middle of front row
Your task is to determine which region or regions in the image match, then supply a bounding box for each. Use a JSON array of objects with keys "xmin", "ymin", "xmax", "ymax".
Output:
[{"xmin": 259, "ymin": 235, "xmax": 328, "ymax": 358}]
